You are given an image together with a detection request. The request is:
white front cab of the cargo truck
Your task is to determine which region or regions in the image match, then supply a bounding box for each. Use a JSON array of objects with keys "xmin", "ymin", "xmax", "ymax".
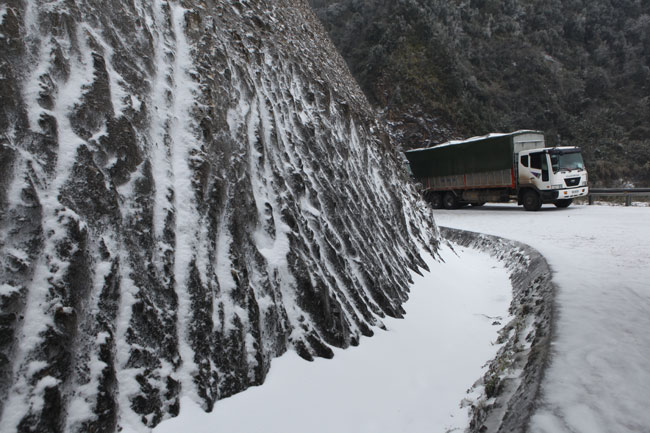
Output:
[{"xmin": 516, "ymin": 146, "xmax": 589, "ymax": 210}]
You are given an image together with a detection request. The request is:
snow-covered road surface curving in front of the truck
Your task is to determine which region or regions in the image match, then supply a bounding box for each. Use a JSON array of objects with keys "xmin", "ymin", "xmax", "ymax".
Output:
[{"xmin": 436, "ymin": 205, "xmax": 650, "ymax": 433}]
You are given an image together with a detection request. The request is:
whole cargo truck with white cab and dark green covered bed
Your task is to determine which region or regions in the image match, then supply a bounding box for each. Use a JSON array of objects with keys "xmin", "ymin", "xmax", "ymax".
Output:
[{"xmin": 405, "ymin": 130, "xmax": 589, "ymax": 211}]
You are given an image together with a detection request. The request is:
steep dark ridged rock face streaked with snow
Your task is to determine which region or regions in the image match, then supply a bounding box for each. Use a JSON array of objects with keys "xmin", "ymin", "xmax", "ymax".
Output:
[{"xmin": 0, "ymin": 0, "xmax": 437, "ymax": 432}]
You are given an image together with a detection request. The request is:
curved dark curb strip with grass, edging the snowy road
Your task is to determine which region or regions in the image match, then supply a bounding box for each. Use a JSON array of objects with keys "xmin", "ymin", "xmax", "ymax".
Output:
[{"xmin": 440, "ymin": 227, "xmax": 555, "ymax": 433}]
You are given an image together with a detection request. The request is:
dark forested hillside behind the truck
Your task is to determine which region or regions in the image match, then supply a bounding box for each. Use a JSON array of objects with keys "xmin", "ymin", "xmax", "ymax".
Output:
[{"xmin": 310, "ymin": 0, "xmax": 650, "ymax": 186}]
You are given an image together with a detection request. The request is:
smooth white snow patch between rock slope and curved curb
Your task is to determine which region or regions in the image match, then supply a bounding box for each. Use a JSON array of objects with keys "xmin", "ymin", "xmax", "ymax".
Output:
[{"xmin": 147, "ymin": 247, "xmax": 512, "ymax": 433}]
